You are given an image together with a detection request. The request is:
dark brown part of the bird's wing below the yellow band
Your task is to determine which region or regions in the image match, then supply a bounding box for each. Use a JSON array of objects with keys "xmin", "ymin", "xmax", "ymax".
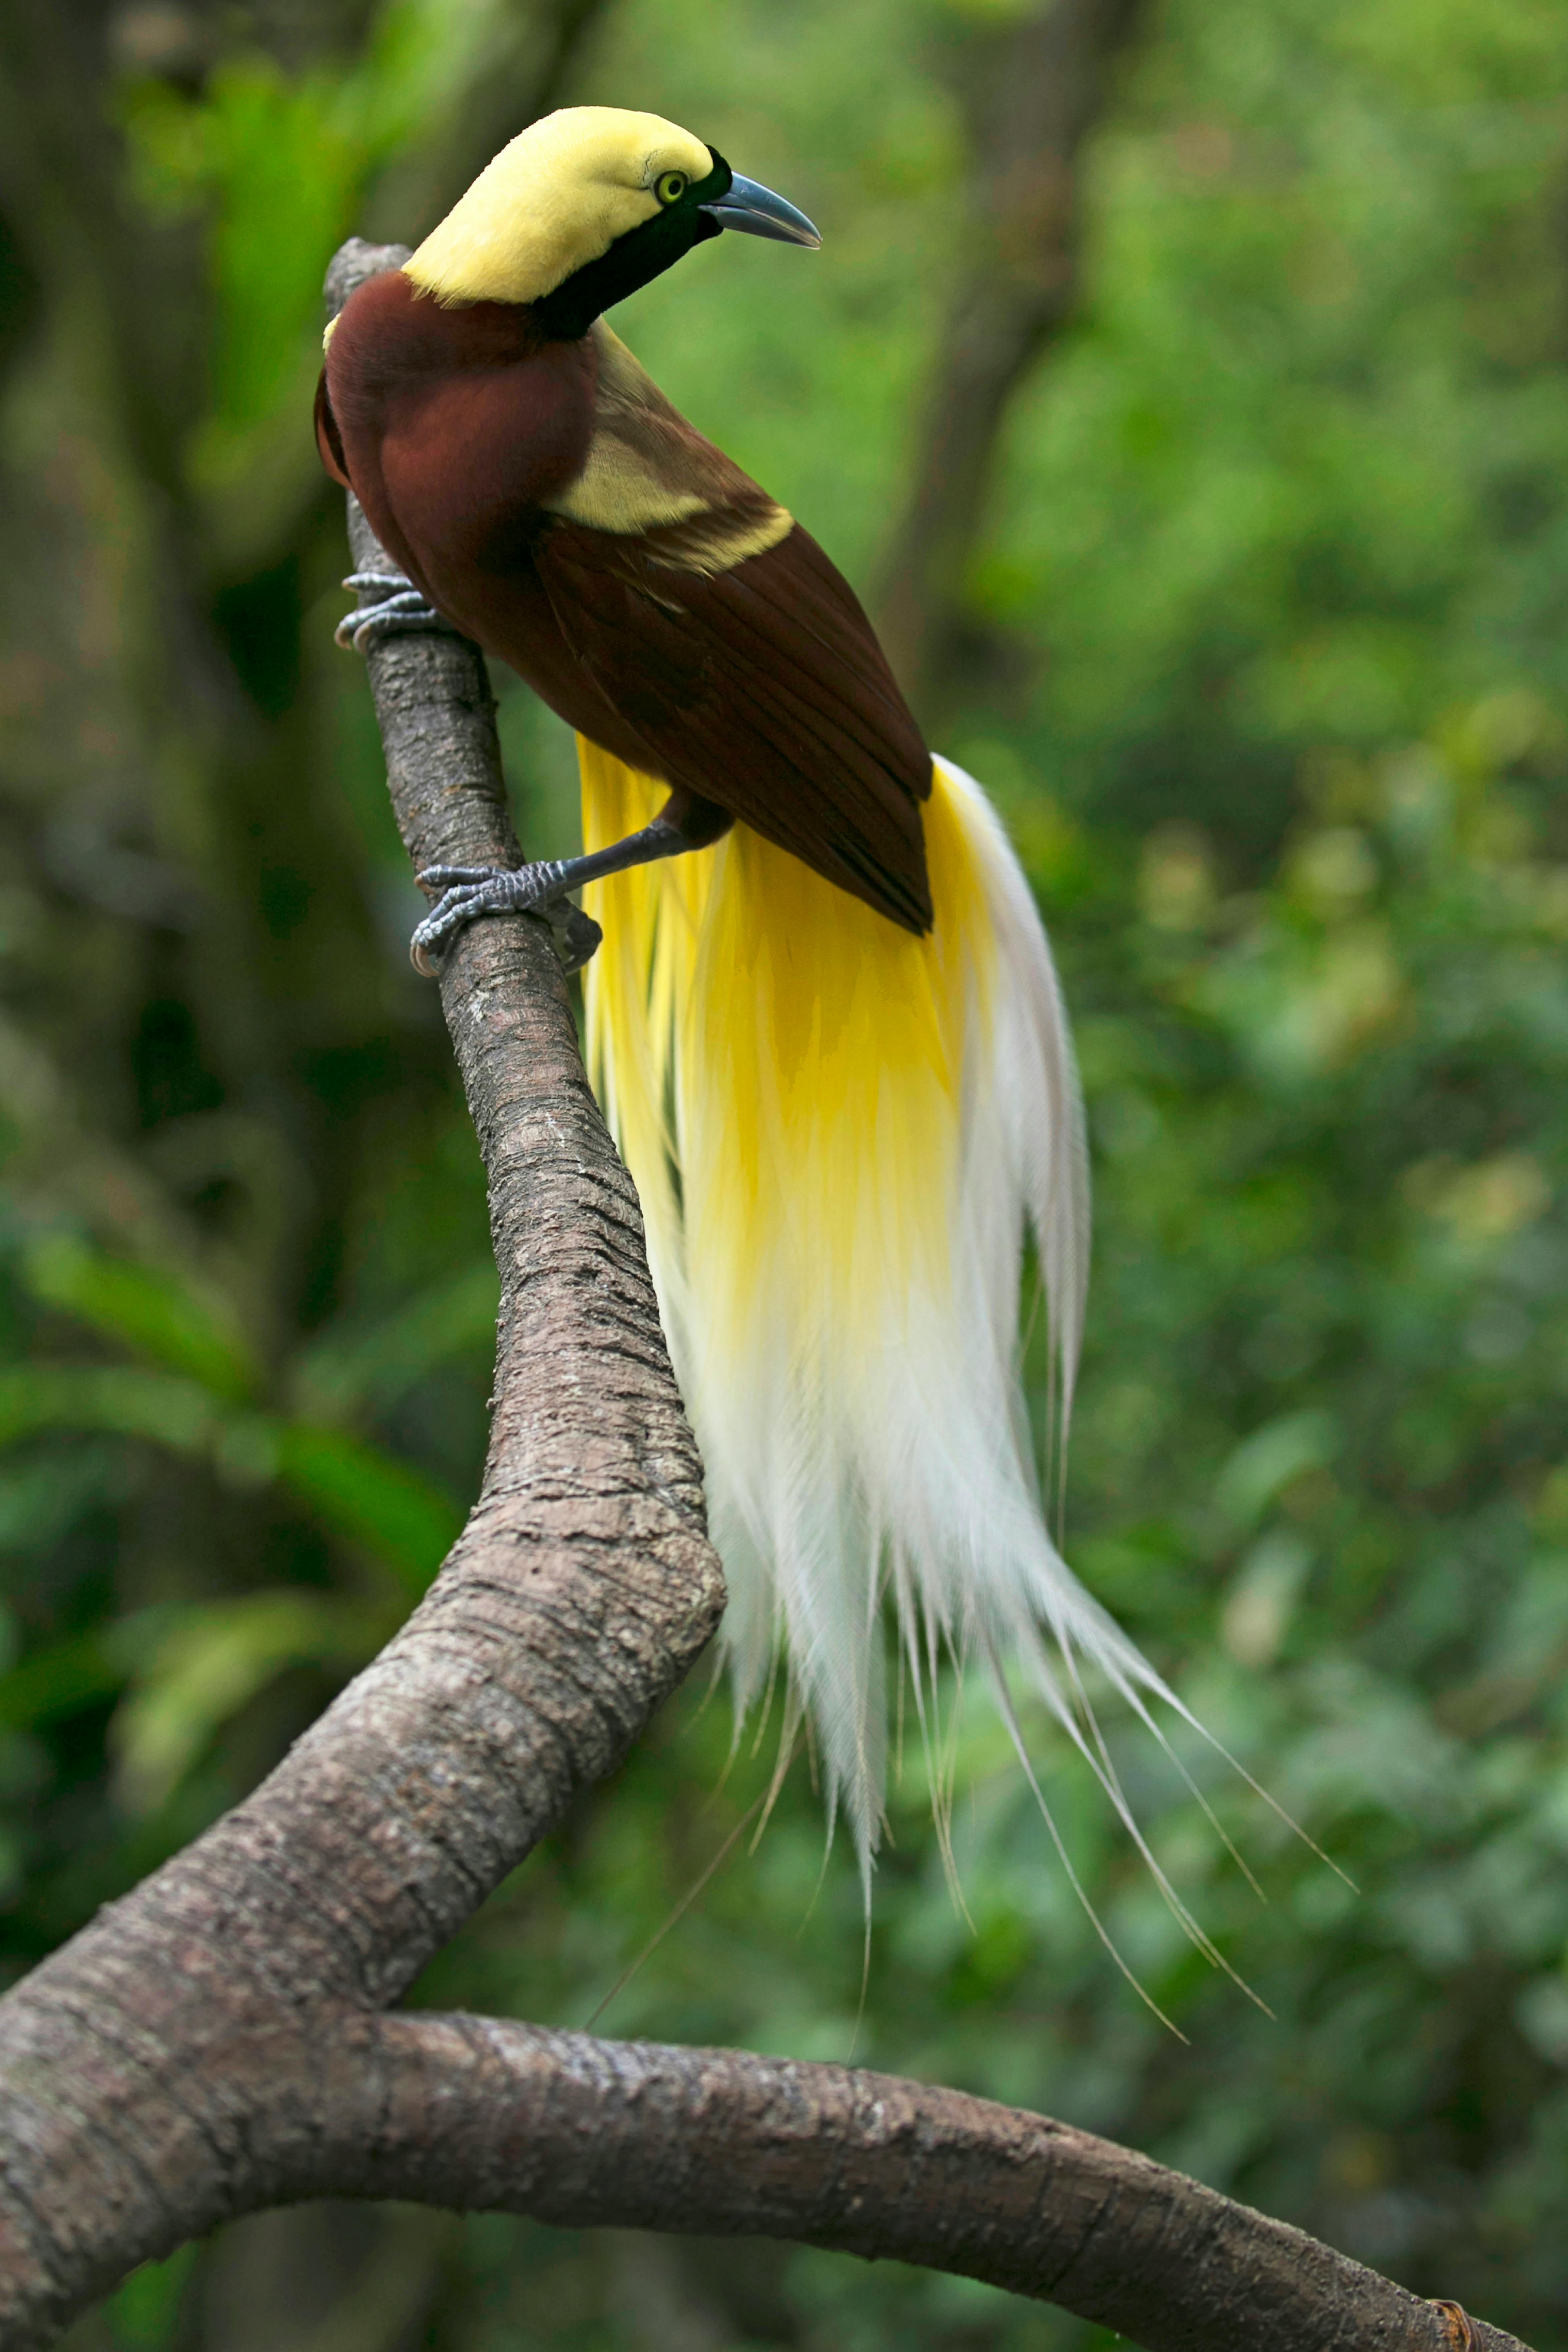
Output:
[{"xmin": 534, "ymin": 520, "xmax": 931, "ymax": 931}]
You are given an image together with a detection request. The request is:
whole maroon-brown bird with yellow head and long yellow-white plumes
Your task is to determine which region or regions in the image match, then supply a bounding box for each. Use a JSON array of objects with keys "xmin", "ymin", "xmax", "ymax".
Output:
[{"xmin": 317, "ymin": 106, "xmax": 1185, "ymax": 1910}]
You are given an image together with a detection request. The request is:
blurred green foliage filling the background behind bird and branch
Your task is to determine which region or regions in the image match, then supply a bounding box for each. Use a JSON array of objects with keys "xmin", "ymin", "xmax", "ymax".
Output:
[{"xmin": 0, "ymin": 0, "xmax": 1568, "ymax": 2352}]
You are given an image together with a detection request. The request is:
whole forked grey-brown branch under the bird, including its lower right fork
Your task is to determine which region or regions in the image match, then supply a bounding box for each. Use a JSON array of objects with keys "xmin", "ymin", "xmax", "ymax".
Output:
[{"xmin": 0, "ymin": 245, "xmax": 1521, "ymax": 2352}]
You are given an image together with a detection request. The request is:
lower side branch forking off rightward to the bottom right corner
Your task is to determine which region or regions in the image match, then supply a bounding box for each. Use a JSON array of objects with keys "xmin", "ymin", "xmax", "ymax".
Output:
[{"xmin": 233, "ymin": 2016, "xmax": 1523, "ymax": 2352}]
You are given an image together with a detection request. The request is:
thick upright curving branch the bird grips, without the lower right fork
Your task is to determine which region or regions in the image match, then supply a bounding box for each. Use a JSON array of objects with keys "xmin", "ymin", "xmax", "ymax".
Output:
[{"xmin": 0, "ymin": 247, "xmax": 724, "ymax": 2347}]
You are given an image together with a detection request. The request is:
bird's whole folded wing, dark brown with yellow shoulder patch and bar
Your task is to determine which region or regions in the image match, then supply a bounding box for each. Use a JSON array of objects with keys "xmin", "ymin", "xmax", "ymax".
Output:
[{"xmin": 534, "ymin": 322, "xmax": 931, "ymax": 931}]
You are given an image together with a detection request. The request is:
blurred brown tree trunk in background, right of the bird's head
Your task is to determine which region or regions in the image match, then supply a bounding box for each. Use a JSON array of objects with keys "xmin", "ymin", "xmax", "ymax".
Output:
[{"xmin": 877, "ymin": 0, "xmax": 1145, "ymax": 727}]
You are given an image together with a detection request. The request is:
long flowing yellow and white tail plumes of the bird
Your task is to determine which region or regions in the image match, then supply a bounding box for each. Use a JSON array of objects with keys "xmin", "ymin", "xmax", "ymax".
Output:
[{"xmin": 578, "ymin": 741, "xmax": 1185, "ymax": 1870}]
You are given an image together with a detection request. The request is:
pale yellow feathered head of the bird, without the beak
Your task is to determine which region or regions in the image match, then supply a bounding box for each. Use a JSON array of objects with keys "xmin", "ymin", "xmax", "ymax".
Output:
[{"xmin": 407, "ymin": 106, "xmax": 729, "ymax": 304}]
